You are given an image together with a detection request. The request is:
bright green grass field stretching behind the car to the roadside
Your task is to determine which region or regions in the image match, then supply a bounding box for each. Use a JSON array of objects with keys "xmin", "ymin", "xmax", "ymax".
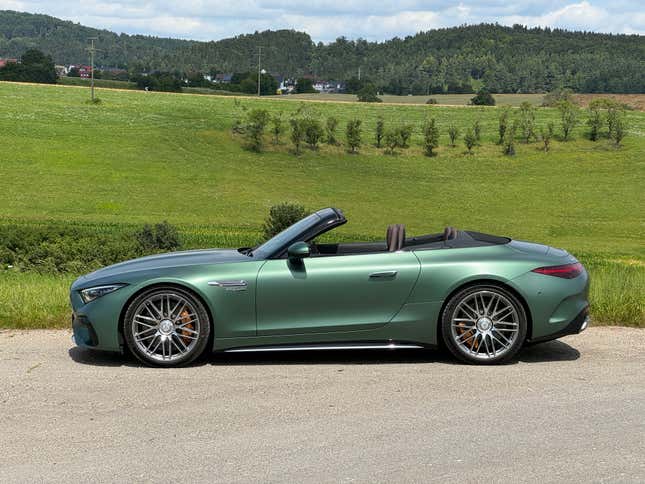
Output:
[{"xmin": 0, "ymin": 83, "xmax": 645, "ymax": 327}]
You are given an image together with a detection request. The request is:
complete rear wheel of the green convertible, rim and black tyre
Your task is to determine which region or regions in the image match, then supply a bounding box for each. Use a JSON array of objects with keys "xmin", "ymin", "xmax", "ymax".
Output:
[{"xmin": 441, "ymin": 285, "xmax": 527, "ymax": 364}]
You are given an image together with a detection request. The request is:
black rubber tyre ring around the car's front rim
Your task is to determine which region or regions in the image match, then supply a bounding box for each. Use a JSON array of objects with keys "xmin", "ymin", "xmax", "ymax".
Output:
[{"xmin": 123, "ymin": 286, "xmax": 211, "ymax": 367}]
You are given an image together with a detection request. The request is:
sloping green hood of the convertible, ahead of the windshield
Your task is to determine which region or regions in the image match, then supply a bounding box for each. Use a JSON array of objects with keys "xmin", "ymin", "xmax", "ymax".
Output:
[{"xmin": 74, "ymin": 249, "xmax": 252, "ymax": 285}]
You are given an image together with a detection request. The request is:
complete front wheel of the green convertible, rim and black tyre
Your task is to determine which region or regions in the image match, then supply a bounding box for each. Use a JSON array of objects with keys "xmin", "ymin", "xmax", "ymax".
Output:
[{"xmin": 123, "ymin": 287, "xmax": 210, "ymax": 366}]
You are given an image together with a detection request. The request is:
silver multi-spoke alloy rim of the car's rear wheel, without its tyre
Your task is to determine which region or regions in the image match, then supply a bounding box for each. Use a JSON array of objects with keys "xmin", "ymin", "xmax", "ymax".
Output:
[{"xmin": 450, "ymin": 290, "xmax": 520, "ymax": 360}]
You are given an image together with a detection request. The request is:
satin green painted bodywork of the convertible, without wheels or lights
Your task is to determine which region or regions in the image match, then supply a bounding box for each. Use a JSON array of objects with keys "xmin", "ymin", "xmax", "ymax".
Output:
[{"xmin": 71, "ymin": 237, "xmax": 589, "ymax": 350}]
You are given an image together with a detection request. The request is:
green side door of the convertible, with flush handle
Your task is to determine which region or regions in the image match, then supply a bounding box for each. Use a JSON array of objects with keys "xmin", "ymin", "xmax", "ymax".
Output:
[{"xmin": 256, "ymin": 252, "xmax": 420, "ymax": 335}]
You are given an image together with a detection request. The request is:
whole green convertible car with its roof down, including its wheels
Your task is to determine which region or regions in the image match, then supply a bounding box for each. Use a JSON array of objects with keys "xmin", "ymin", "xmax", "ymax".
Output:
[{"xmin": 71, "ymin": 208, "xmax": 589, "ymax": 366}]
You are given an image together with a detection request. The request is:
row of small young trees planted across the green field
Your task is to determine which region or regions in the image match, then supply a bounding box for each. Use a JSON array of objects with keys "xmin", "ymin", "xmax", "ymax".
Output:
[{"xmin": 233, "ymin": 99, "xmax": 627, "ymax": 156}]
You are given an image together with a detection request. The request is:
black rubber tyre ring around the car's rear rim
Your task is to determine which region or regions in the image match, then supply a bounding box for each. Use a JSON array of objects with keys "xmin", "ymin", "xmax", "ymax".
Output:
[{"xmin": 441, "ymin": 284, "xmax": 528, "ymax": 365}]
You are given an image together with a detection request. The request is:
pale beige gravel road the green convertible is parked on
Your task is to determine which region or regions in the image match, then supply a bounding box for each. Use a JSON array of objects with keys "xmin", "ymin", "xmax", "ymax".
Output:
[{"xmin": 0, "ymin": 327, "xmax": 645, "ymax": 484}]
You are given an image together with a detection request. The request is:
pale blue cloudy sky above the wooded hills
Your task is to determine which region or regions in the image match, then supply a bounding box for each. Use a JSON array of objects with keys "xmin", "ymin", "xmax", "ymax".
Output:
[{"xmin": 0, "ymin": 0, "xmax": 645, "ymax": 42}]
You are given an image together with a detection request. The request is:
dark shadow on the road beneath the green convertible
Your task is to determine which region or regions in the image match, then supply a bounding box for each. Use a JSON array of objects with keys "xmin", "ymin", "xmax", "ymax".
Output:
[{"xmin": 68, "ymin": 341, "xmax": 580, "ymax": 367}]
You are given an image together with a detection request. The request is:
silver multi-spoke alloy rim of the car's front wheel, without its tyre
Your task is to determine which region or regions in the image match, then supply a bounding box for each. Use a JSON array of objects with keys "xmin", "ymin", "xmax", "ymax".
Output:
[{"xmin": 131, "ymin": 292, "xmax": 202, "ymax": 361}]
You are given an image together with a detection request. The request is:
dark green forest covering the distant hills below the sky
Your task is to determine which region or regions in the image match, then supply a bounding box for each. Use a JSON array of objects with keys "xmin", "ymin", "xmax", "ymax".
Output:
[{"xmin": 0, "ymin": 11, "xmax": 645, "ymax": 95}]
